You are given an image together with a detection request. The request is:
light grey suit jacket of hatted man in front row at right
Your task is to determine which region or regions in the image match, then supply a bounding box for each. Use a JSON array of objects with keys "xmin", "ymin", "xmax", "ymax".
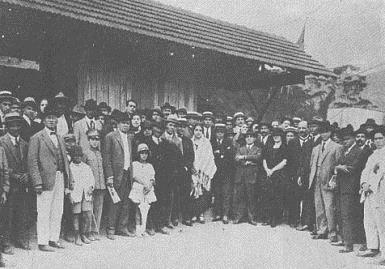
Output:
[{"xmin": 309, "ymin": 140, "xmax": 342, "ymax": 189}]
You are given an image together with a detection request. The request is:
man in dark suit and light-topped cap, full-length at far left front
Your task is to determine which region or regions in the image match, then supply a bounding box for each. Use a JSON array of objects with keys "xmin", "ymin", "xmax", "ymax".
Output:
[{"xmin": 0, "ymin": 112, "xmax": 31, "ymax": 251}]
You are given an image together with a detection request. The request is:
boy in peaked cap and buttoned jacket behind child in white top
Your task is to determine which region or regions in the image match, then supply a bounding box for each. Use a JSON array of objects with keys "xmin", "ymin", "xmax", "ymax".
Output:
[{"xmin": 84, "ymin": 129, "xmax": 106, "ymax": 241}]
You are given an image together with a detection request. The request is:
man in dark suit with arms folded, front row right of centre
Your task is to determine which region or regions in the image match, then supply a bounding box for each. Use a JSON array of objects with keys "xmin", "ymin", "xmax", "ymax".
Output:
[{"xmin": 233, "ymin": 131, "xmax": 262, "ymax": 225}]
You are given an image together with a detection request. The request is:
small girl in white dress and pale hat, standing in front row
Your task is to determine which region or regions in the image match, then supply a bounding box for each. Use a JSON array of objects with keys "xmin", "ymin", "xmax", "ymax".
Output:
[{"xmin": 129, "ymin": 144, "xmax": 156, "ymax": 236}]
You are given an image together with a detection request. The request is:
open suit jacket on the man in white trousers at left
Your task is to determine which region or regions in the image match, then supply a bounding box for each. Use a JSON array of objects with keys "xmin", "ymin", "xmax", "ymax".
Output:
[{"xmin": 28, "ymin": 129, "xmax": 73, "ymax": 191}]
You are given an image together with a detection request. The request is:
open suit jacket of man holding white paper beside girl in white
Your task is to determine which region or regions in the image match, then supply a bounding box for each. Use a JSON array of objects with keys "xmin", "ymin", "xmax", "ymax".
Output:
[{"xmin": 103, "ymin": 130, "xmax": 133, "ymax": 188}]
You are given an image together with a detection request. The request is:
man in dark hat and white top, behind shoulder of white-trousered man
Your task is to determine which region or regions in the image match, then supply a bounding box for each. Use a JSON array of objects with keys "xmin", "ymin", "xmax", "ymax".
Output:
[{"xmin": 53, "ymin": 92, "xmax": 73, "ymax": 136}]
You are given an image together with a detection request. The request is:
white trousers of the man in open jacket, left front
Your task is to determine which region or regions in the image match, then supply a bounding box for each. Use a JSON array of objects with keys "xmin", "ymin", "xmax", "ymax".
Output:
[{"xmin": 37, "ymin": 172, "xmax": 64, "ymax": 245}]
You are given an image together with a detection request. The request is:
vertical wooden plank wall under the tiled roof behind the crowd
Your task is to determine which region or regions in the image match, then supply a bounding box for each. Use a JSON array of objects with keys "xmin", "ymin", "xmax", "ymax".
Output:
[{"xmin": 77, "ymin": 46, "xmax": 201, "ymax": 110}]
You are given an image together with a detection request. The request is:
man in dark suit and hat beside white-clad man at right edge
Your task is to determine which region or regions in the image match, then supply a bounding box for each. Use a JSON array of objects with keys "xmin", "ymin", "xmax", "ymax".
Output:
[{"xmin": 334, "ymin": 128, "xmax": 365, "ymax": 253}]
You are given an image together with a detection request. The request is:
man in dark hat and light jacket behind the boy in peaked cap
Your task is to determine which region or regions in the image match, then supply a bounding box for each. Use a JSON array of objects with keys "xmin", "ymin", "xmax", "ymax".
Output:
[{"xmin": 74, "ymin": 99, "xmax": 101, "ymax": 150}]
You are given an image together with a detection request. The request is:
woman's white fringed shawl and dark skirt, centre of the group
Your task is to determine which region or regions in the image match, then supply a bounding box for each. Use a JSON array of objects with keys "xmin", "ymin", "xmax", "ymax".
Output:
[{"xmin": 190, "ymin": 137, "xmax": 217, "ymax": 215}]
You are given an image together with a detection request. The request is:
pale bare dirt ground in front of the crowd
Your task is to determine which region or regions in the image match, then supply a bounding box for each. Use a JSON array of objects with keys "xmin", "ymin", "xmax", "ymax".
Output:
[{"xmin": 4, "ymin": 222, "xmax": 380, "ymax": 269}]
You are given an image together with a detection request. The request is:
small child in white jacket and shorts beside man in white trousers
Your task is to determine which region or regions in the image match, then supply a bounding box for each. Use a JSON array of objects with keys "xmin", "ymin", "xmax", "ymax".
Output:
[{"xmin": 70, "ymin": 145, "xmax": 95, "ymax": 246}]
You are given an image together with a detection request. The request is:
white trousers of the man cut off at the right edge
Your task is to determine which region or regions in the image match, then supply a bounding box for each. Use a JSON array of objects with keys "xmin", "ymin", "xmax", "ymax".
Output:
[{"xmin": 364, "ymin": 193, "xmax": 385, "ymax": 254}]
